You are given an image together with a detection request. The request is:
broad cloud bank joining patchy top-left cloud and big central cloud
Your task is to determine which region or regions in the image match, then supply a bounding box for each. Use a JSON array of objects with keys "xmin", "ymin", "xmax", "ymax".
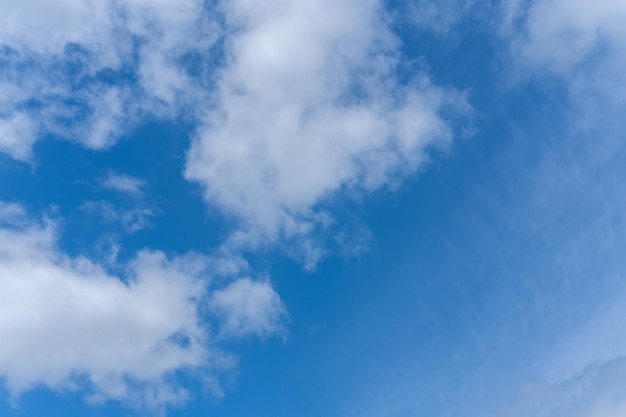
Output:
[{"xmin": 0, "ymin": 0, "xmax": 466, "ymax": 247}]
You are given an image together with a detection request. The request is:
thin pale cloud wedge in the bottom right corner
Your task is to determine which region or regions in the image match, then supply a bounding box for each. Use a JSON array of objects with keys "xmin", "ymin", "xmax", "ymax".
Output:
[{"xmin": 497, "ymin": 290, "xmax": 626, "ymax": 417}]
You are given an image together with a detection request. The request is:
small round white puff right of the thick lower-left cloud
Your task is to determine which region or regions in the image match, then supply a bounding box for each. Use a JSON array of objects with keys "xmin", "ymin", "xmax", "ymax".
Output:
[{"xmin": 209, "ymin": 278, "xmax": 285, "ymax": 337}]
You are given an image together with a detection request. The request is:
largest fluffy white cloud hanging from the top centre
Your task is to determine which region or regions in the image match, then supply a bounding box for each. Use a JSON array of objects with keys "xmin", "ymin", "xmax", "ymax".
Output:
[{"xmin": 186, "ymin": 0, "xmax": 464, "ymax": 246}]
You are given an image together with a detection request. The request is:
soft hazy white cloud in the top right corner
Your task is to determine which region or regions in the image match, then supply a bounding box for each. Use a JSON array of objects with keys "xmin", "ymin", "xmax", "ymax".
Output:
[{"xmin": 505, "ymin": 0, "xmax": 626, "ymax": 115}]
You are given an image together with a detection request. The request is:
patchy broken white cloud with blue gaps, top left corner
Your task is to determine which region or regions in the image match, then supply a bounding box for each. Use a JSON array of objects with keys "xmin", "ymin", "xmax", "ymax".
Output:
[{"xmin": 0, "ymin": 0, "xmax": 216, "ymax": 159}]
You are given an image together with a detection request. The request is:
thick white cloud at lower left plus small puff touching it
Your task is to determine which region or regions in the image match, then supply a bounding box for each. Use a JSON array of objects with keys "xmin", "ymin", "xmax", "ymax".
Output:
[{"xmin": 0, "ymin": 203, "xmax": 282, "ymax": 407}]
